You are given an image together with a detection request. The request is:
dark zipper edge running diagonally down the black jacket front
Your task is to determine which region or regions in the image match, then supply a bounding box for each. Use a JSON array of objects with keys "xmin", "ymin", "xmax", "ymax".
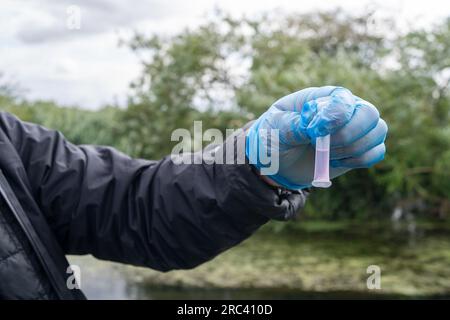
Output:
[{"xmin": 0, "ymin": 169, "xmax": 73, "ymax": 300}]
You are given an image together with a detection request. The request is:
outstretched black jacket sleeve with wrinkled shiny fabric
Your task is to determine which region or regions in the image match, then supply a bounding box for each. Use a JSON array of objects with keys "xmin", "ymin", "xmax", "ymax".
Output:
[{"xmin": 0, "ymin": 113, "xmax": 305, "ymax": 271}]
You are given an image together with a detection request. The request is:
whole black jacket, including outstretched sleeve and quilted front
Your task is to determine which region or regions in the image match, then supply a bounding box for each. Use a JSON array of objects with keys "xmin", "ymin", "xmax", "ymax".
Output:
[{"xmin": 0, "ymin": 113, "xmax": 306, "ymax": 299}]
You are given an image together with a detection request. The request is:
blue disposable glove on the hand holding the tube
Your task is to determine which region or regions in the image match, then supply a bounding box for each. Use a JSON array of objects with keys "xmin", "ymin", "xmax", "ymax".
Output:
[{"xmin": 246, "ymin": 86, "xmax": 387, "ymax": 190}]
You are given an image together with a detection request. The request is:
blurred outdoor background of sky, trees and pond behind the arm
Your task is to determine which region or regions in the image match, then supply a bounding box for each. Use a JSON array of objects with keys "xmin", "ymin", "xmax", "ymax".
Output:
[{"xmin": 0, "ymin": 0, "xmax": 450, "ymax": 299}]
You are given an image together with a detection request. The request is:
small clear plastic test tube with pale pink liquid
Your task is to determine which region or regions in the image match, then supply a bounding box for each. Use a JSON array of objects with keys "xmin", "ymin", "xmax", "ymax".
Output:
[{"xmin": 312, "ymin": 135, "xmax": 331, "ymax": 188}]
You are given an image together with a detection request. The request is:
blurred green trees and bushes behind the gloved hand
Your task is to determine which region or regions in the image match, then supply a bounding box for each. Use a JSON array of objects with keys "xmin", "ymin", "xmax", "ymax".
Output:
[{"xmin": 0, "ymin": 10, "xmax": 450, "ymax": 219}]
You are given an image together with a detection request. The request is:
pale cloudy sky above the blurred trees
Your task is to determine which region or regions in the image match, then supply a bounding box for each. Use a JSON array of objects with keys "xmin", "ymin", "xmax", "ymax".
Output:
[{"xmin": 0, "ymin": 0, "xmax": 450, "ymax": 109}]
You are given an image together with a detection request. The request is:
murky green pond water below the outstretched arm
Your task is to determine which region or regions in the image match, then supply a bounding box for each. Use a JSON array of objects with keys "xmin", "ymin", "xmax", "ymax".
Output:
[{"xmin": 69, "ymin": 222, "xmax": 450, "ymax": 299}]
